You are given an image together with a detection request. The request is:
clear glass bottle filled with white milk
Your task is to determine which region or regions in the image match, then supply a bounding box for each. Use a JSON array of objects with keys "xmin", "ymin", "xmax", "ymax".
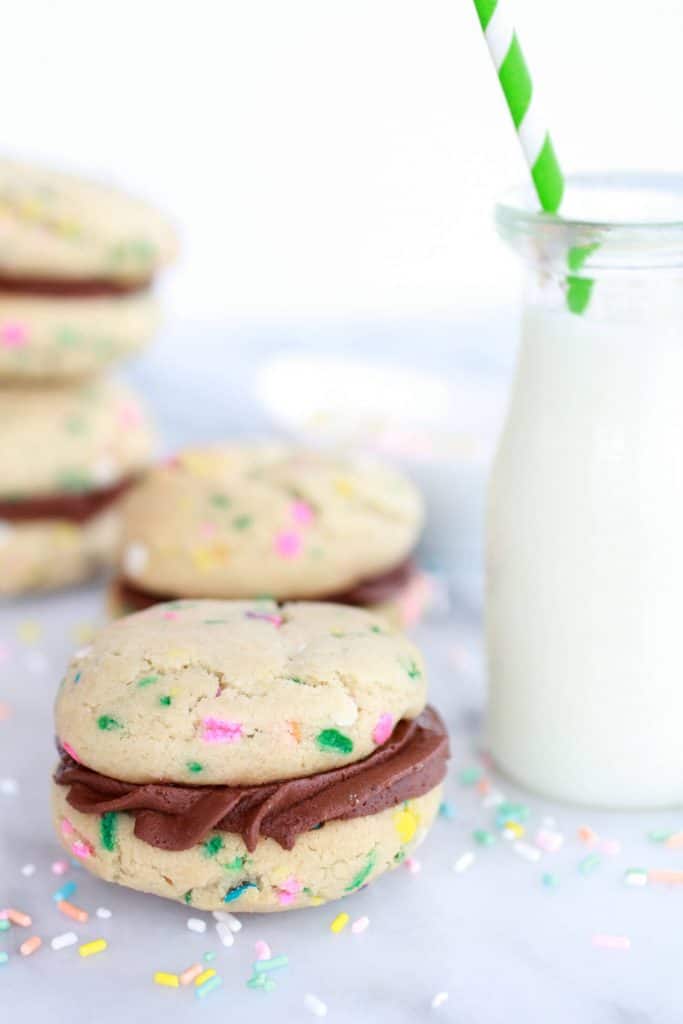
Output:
[{"xmin": 486, "ymin": 175, "xmax": 683, "ymax": 808}]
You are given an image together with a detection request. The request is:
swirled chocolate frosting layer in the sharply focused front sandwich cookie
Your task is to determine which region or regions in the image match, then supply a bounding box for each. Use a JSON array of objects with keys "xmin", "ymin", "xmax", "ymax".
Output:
[{"xmin": 54, "ymin": 708, "xmax": 450, "ymax": 852}]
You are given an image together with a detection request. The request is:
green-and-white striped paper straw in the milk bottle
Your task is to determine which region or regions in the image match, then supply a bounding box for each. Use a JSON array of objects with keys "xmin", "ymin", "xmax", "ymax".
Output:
[{"xmin": 474, "ymin": 0, "xmax": 596, "ymax": 313}]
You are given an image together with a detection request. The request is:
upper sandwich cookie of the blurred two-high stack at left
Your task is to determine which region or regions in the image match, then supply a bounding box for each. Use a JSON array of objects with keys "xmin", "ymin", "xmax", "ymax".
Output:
[{"xmin": 0, "ymin": 161, "xmax": 176, "ymax": 381}]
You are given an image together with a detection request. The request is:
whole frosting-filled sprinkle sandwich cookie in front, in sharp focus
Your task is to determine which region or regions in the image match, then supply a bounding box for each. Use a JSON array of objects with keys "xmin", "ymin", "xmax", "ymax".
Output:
[{"xmin": 53, "ymin": 600, "xmax": 449, "ymax": 910}]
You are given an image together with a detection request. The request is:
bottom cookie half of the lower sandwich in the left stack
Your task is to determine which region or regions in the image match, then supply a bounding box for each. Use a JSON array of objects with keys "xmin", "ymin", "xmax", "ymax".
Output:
[{"xmin": 0, "ymin": 509, "xmax": 120, "ymax": 597}]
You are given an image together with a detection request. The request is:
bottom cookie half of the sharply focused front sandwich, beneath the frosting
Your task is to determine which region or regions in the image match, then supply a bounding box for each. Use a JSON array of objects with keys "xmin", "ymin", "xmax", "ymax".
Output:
[{"xmin": 52, "ymin": 783, "xmax": 441, "ymax": 912}]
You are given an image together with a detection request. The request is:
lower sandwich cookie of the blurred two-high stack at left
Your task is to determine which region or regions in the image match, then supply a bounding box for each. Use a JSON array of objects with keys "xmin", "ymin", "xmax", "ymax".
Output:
[{"xmin": 0, "ymin": 380, "xmax": 155, "ymax": 595}]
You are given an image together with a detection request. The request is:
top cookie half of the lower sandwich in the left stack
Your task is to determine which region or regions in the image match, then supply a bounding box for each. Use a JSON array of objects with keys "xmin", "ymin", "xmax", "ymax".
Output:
[{"xmin": 0, "ymin": 379, "xmax": 156, "ymax": 501}]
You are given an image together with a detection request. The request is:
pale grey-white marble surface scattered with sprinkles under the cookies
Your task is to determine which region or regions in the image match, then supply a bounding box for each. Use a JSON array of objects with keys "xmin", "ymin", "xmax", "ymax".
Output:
[{"xmin": 0, "ymin": 319, "xmax": 683, "ymax": 1024}]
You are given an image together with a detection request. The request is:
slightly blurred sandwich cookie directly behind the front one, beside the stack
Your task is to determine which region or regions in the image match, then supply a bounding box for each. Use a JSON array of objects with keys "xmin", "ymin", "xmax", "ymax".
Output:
[{"xmin": 115, "ymin": 443, "xmax": 426, "ymax": 624}]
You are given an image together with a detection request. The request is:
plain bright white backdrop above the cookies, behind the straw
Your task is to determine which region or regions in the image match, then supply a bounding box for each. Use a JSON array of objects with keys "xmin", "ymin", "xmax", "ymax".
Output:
[{"xmin": 5, "ymin": 0, "xmax": 683, "ymax": 321}]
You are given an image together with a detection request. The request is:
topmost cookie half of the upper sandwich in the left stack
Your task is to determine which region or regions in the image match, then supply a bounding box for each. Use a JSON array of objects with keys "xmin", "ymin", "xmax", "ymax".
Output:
[{"xmin": 0, "ymin": 160, "xmax": 177, "ymax": 282}]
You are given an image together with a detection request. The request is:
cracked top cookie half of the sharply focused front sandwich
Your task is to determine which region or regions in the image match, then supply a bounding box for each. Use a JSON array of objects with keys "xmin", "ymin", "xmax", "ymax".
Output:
[{"xmin": 55, "ymin": 600, "xmax": 426, "ymax": 785}]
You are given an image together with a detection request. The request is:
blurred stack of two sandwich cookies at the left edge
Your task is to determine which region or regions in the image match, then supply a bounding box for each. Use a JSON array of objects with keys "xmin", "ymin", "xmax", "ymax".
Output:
[{"xmin": 0, "ymin": 161, "xmax": 176, "ymax": 595}]
